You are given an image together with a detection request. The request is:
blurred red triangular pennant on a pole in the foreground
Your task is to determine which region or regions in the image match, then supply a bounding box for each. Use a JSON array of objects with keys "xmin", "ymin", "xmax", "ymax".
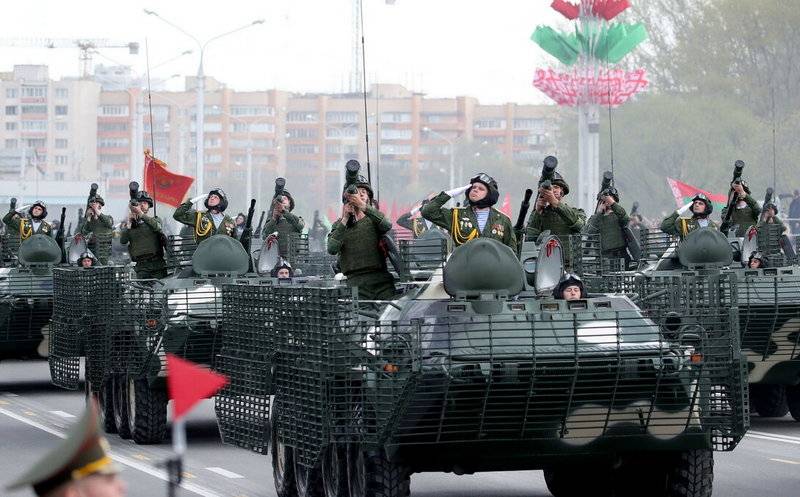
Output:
[{"xmin": 167, "ymin": 354, "xmax": 228, "ymax": 420}]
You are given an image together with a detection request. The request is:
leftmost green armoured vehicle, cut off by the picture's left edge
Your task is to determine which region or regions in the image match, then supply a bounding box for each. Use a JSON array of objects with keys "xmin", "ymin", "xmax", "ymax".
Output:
[{"xmin": 0, "ymin": 234, "xmax": 62, "ymax": 359}]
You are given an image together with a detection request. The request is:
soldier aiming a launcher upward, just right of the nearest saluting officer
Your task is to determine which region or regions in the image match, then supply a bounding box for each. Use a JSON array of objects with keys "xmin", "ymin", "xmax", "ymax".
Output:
[{"xmin": 525, "ymin": 173, "xmax": 586, "ymax": 267}]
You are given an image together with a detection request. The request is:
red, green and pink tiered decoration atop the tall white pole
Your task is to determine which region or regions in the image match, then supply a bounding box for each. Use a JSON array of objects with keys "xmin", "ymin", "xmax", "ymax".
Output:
[{"xmin": 531, "ymin": 0, "xmax": 648, "ymax": 106}]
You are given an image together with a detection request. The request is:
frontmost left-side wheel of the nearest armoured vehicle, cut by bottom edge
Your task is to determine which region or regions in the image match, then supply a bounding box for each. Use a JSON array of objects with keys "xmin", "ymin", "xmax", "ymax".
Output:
[{"xmin": 347, "ymin": 444, "xmax": 411, "ymax": 497}]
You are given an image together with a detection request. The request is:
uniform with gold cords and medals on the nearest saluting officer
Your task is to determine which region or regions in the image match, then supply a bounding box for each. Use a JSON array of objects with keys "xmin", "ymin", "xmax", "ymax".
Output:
[{"xmin": 420, "ymin": 192, "xmax": 517, "ymax": 253}]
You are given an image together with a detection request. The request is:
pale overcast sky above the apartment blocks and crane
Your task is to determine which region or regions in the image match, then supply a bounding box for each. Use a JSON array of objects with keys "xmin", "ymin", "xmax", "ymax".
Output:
[{"xmin": 0, "ymin": 0, "xmax": 565, "ymax": 103}]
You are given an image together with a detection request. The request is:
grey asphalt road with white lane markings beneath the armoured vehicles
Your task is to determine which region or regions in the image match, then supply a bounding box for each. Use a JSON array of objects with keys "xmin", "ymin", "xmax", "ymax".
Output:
[{"xmin": 0, "ymin": 361, "xmax": 800, "ymax": 497}]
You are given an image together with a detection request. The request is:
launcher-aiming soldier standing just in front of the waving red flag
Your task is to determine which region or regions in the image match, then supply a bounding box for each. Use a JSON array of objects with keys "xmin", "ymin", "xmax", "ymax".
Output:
[{"xmin": 119, "ymin": 190, "xmax": 167, "ymax": 279}]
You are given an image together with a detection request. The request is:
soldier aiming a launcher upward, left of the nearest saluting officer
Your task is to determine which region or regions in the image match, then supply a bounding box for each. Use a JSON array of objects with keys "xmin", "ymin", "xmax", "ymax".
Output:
[{"xmin": 328, "ymin": 175, "xmax": 396, "ymax": 300}]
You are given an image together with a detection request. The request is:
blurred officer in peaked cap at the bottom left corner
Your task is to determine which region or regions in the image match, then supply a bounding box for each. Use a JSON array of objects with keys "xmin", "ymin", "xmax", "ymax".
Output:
[{"xmin": 7, "ymin": 402, "xmax": 126, "ymax": 497}]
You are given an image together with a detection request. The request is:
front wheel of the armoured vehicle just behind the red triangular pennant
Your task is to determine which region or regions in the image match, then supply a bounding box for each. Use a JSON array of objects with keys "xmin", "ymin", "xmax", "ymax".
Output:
[{"xmin": 127, "ymin": 378, "xmax": 169, "ymax": 445}]
